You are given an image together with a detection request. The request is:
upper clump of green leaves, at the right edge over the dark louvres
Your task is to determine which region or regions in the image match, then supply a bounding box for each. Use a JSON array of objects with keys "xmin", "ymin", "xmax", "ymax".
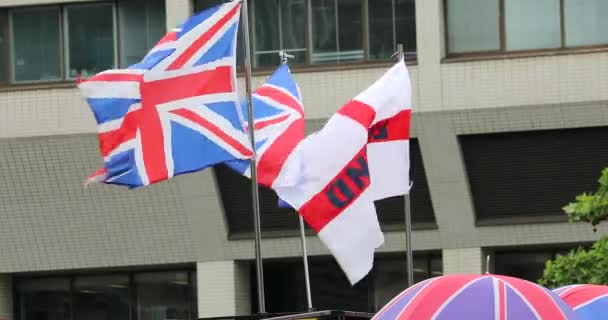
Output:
[{"xmin": 563, "ymin": 168, "xmax": 608, "ymax": 231}]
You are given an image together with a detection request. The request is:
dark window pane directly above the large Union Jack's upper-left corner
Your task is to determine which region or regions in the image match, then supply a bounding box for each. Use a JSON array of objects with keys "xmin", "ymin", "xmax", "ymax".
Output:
[{"xmin": 66, "ymin": 4, "xmax": 114, "ymax": 78}]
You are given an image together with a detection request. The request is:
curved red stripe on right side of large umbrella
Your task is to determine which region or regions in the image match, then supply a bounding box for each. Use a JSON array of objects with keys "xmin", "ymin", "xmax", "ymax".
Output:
[{"xmin": 494, "ymin": 275, "xmax": 566, "ymax": 320}]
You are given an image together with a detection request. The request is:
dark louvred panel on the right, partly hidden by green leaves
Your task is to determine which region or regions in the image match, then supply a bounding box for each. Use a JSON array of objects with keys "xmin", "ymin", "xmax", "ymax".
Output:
[{"xmin": 459, "ymin": 127, "xmax": 608, "ymax": 221}]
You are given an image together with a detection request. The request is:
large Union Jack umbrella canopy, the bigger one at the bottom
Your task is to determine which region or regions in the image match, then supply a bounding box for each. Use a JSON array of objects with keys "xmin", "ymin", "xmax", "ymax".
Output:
[{"xmin": 372, "ymin": 274, "xmax": 579, "ymax": 320}]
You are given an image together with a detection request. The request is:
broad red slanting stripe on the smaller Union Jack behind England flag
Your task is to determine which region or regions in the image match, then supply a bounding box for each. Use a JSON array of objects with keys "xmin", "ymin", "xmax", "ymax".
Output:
[{"xmin": 256, "ymin": 119, "xmax": 304, "ymax": 187}]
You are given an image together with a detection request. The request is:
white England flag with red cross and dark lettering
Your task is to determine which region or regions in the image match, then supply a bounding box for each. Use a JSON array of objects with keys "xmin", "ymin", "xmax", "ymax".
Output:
[{"xmin": 273, "ymin": 60, "xmax": 411, "ymax": 284}]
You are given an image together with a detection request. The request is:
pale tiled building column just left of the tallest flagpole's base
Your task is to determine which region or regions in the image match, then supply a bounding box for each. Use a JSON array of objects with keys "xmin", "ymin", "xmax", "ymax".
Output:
[{"xmin": 196, "ymin": 260, "xmax": 251, "ymax": 318}]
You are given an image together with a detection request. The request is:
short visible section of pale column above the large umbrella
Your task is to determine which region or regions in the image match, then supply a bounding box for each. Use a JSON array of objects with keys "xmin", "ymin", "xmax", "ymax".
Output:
[{"xmin": 443, "ymin": 248, "xmax": 484, "ymax": 275}]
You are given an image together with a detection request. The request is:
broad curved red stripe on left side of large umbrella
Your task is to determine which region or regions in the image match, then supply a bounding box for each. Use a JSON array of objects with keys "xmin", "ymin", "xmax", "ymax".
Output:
[{"xmin": 399, "ymin": 274, "xmax": 480, "ymax": 319}]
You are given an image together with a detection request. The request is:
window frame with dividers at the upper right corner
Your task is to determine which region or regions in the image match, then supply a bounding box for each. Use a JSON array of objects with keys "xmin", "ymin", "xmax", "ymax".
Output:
[{"xmin": 443, "ymin": 0, "xmax": 608, "ymax": 58}]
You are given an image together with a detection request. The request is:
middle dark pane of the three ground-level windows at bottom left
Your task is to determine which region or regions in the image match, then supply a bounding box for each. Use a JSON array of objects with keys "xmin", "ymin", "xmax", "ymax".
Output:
[{"xmin": 74, "ymin": 275, "xmax": 130, "ymax": 320}]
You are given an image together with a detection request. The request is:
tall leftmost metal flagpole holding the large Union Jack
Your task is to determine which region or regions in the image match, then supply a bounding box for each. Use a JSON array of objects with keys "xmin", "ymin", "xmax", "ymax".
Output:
[{"xmin": 241, "ymin": 0, "xmax": 266, "ymax": 313}]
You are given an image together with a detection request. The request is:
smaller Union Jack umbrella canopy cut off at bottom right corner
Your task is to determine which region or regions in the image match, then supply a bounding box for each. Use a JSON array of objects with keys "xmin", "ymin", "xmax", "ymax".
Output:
[{"xmin": 553, "ymin": 284, "xmax": 608, "ymax": 320}]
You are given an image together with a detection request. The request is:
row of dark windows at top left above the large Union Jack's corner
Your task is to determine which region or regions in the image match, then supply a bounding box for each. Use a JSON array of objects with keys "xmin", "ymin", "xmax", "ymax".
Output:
[{"xmin": 0, "ymin": 0, "xmax": 166, "ymax": 83}]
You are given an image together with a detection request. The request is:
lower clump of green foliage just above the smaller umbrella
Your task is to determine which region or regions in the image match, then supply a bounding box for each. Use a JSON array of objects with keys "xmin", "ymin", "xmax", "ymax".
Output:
[{"xmin": 538, "ymin": 237, "xmax": 608, "ymax": 288}]
